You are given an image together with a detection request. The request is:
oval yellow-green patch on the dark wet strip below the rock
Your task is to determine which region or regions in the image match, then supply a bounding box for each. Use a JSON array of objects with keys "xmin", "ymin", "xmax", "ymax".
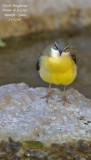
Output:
[{"xmin": 22, "ymin": 141, "xmax": 43, "ymax": 149}]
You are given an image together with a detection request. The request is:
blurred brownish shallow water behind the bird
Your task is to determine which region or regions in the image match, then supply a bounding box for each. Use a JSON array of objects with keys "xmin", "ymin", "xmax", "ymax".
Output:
[{"xmin": 0, "ymin": 33, "xmax": 91, "ymax": 98}]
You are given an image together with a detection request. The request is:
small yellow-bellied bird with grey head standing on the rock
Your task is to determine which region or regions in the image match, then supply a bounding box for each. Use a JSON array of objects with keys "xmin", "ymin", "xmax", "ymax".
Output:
[{"xmin": 36, "ymin": 41, "xmax": 77, "ymax": 105}]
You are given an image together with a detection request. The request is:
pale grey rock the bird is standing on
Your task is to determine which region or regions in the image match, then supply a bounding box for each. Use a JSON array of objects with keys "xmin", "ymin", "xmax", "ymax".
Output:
[{"xmin": 0, "ymin": 83, "xmax": 91, "ymax": 145}]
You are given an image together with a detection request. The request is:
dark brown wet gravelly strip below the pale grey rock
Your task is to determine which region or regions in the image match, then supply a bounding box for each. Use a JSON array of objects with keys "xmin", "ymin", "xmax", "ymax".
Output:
[{"xmin": 0, "ymin": 138, "xmax": 91, "ymax": 160}]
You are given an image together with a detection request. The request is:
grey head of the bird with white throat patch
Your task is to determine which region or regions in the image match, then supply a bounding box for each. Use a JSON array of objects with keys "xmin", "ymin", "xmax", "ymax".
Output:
[{"xmin": 51, "ymin": 42, "xmax": 69, "ymax": 57}]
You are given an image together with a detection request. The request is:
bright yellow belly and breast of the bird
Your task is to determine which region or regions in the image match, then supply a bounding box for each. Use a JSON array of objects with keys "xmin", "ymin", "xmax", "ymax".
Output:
[{"xmin": 39, "ymin": 56, "xmax": 77, "ymax": 85}]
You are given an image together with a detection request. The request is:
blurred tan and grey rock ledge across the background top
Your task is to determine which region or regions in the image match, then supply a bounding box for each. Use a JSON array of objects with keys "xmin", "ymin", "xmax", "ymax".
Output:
[{"xmin": 0, "ymin": 0, "xmax": 91, "ymax": 38}]
